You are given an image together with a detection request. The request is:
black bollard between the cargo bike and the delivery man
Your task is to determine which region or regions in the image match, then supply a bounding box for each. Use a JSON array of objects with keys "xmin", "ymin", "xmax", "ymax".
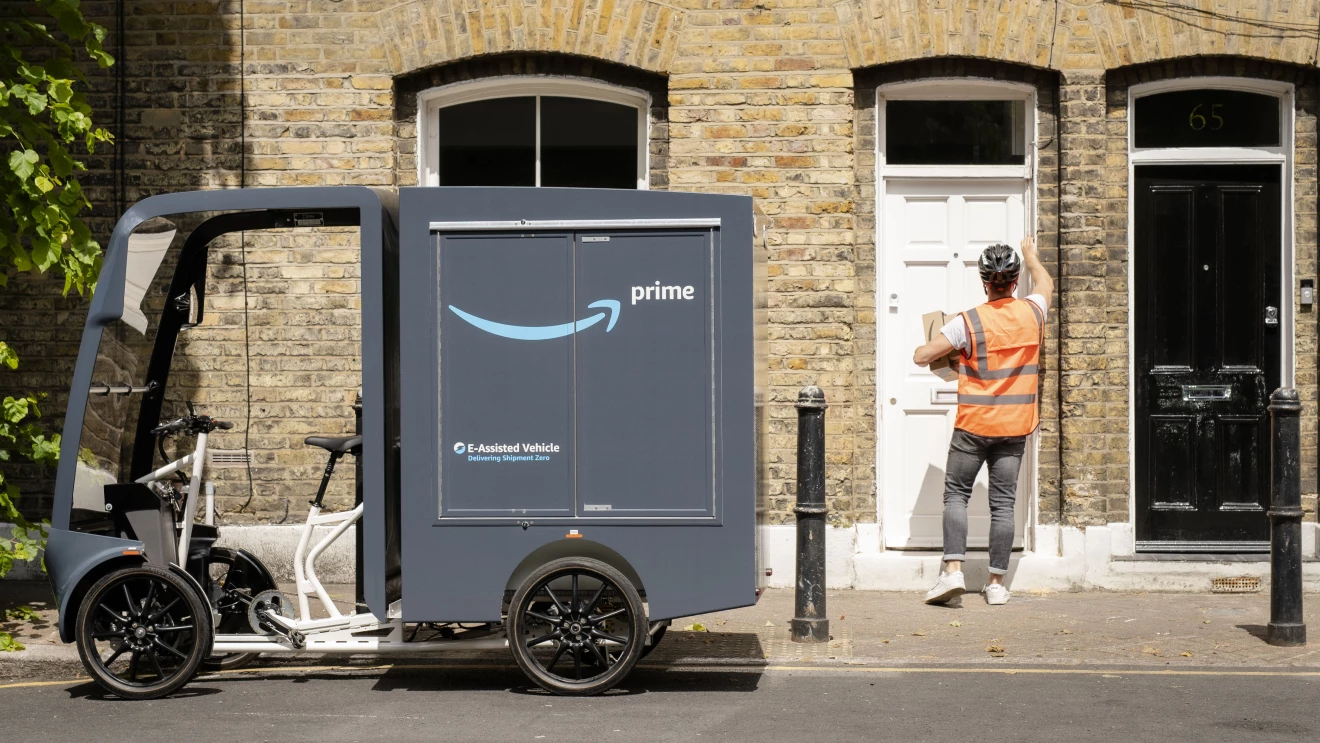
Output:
[{"xmin": 792, "ymin": 385, "xmax": 829, "ymax": 643}]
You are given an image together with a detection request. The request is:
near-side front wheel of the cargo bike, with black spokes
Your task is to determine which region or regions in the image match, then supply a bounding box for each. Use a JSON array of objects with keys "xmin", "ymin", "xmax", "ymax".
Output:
[{"xmin": 77, "ymin": 565, "xmax": 213, "ymax": 699}]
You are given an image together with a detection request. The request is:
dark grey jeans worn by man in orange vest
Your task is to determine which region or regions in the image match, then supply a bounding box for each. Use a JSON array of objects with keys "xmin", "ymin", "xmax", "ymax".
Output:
[{"xmin": 944, "ymin": 429, "xmax": 1027, "ymax": 575}]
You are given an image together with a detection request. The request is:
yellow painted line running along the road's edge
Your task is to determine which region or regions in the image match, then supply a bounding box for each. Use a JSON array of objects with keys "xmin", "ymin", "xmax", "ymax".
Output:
[{"xmin": 0, "ymin": 664, "xmax": 1320, "ymax": 689}]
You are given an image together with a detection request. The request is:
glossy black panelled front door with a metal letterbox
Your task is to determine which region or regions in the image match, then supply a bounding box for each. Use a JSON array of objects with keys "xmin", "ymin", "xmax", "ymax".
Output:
[{"xmin": 1133, "ymin": 165, "xmax": 1282, "ymax": 552}]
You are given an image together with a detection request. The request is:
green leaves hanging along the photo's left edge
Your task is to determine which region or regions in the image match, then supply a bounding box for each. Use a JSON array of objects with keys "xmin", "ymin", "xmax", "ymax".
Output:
[{"xmin": 0, "ymin": 0, "xmax": 115, "ymax": 625}]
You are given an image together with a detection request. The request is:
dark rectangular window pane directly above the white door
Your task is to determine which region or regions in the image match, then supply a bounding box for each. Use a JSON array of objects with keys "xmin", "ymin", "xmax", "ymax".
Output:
[{"xmin": 884, "ymin": 100, "xmax": 1027, "ymax": 165}]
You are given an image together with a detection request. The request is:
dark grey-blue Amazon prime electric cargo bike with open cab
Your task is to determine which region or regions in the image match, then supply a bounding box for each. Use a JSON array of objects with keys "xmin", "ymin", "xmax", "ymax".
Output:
[{"xmin": 46, "ymin": 186, "xmax": 766, "ymax": 698}]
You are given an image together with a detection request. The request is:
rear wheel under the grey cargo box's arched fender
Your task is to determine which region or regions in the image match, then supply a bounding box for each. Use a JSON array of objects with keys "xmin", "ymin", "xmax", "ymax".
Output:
[{"xmin": 504, "ymin": 557, "xmax": 649, "ymax": 697}]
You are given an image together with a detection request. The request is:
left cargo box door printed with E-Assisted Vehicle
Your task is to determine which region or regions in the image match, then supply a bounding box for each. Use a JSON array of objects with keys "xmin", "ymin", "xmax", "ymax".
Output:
[{"xmin": 438, "ymin": 234, "xmax": 581, "ymax": 519}]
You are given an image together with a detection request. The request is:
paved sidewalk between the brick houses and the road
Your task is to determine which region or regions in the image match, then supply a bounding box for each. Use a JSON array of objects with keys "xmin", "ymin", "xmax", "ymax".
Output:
[{"xmin": 0, "ymin": 581, "xmax": 1320, "ymax": 676}]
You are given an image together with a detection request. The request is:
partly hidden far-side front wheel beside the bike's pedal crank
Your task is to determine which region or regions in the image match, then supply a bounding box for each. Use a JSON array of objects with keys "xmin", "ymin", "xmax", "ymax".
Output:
[{"xmin": 189, "ymin": 546, "xmax": 276, "ymax": 670}]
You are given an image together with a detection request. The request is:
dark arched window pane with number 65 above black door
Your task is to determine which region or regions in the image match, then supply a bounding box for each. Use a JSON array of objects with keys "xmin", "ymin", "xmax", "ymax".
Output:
[{"xmin": 1135, "ymin": 90, "xmax": 1280, "ymax": 146}]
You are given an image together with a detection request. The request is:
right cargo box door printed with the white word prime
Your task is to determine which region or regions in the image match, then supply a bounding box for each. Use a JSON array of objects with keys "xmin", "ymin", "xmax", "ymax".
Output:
[{"xmin": 576, "ymin": 230, "xmax": 717, "ymax": 519}]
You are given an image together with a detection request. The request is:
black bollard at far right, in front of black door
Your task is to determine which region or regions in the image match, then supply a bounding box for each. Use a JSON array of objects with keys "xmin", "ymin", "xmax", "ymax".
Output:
[{"xmin": 1265, "ymin": 388, "xmax": 1307, "ymax": 647}]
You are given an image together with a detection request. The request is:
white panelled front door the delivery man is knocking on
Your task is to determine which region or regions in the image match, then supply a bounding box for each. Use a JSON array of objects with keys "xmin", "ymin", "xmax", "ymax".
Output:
[{"xmin": 878, "ymin": 178, "xmax": 1035, "ymax": 549}]
